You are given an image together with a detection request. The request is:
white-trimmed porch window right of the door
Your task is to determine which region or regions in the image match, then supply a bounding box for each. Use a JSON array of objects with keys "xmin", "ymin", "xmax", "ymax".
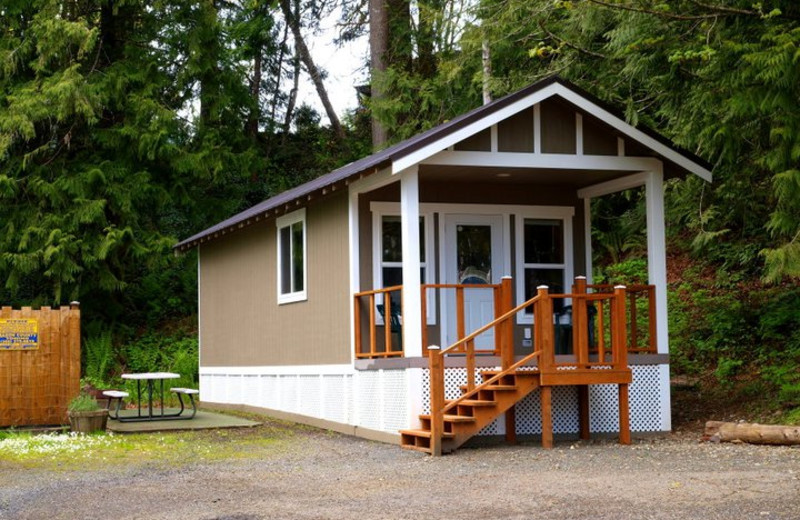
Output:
[{"xmin": 517, "ymin": 208, "xmax": 573, "ymax": 323}]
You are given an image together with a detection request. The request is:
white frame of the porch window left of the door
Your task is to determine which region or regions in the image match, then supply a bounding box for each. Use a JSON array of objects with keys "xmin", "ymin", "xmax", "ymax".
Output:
[{"xmin": 370, "ymin": 202, "xmax": 436, "ymax": 325}]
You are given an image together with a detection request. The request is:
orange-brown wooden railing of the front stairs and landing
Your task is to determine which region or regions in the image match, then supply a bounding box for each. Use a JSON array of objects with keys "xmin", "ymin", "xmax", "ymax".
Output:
[{"xmin": 428, "ymin": 278, "xmax": 628, "ymax": 455}]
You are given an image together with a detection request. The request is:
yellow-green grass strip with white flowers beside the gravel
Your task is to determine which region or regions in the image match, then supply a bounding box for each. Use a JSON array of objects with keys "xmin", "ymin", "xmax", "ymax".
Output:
[{"xmin": 0, "ymin": 416, "xmax": 297, "ymax": 471}]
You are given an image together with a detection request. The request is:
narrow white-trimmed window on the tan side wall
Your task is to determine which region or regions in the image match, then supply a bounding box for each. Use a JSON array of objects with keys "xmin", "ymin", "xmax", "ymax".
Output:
[{"xmin": 275, "ymin": 208, "xmax": 308, "ymax": 304}]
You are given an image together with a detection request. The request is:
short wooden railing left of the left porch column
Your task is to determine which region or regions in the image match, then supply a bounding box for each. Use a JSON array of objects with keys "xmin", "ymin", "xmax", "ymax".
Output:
[{"xmin": 353, "ymin": 285, "xmax": 403, "ymax": 358}]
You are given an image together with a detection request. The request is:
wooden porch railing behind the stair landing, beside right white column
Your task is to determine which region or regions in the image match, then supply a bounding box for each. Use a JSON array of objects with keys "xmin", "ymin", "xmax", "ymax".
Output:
[{"xmin": 572, "ymin": 278, "xmax": 658, "ymax": 354}]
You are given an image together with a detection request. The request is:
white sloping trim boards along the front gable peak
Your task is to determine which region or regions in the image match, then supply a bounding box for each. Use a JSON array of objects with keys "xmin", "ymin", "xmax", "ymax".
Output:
[{"xmin": 392, "ymin": 83, "xmax": 712, "ymax": 182}]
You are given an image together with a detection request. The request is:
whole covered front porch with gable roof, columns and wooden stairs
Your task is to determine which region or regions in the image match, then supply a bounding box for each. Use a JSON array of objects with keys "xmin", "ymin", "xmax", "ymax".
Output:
[{"xmin": 349, "ymin": 83, "xmax": 710, "ymax": 453}]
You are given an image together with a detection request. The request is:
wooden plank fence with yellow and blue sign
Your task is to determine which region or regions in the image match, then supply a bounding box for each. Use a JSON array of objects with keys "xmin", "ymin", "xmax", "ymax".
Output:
[{"xmin": 0, "ymin": 302, "xmax": 81, "ymax": 427}]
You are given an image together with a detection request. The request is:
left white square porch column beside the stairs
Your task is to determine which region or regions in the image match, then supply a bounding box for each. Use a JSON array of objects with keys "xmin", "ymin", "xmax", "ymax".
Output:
[{"xmin": 400, "ymin": 165, "xmax": 422, "ymax": 357}]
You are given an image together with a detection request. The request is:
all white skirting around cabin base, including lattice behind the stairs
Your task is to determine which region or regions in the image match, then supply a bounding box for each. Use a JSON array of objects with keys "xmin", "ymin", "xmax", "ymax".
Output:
[{"xmin": 200, "ymin": 365, "xmax": 671, "ymax": 435}]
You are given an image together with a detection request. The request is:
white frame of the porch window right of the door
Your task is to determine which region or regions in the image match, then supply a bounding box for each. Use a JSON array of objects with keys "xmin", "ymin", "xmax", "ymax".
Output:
[{"xmin": 514, "ymin": 206, "xmax": 576, "ymax": 325}]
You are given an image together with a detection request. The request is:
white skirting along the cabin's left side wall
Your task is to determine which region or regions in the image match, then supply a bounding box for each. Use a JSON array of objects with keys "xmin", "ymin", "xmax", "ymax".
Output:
[{"xmin": 200, "ymin": 365, "xmax": 409, "ymax": 433}]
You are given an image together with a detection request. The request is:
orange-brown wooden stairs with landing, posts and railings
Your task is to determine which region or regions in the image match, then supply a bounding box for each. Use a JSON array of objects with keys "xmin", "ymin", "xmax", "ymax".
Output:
[{"xmin": 400, "ymin": 278, "xmax": 632, "ymax": 455}]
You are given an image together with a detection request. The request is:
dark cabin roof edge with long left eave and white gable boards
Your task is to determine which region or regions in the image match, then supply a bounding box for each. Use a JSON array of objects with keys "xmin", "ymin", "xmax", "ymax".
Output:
[{"xmin": 174, "ymin": 76, "xmax": 712, "ymax": 252}]
